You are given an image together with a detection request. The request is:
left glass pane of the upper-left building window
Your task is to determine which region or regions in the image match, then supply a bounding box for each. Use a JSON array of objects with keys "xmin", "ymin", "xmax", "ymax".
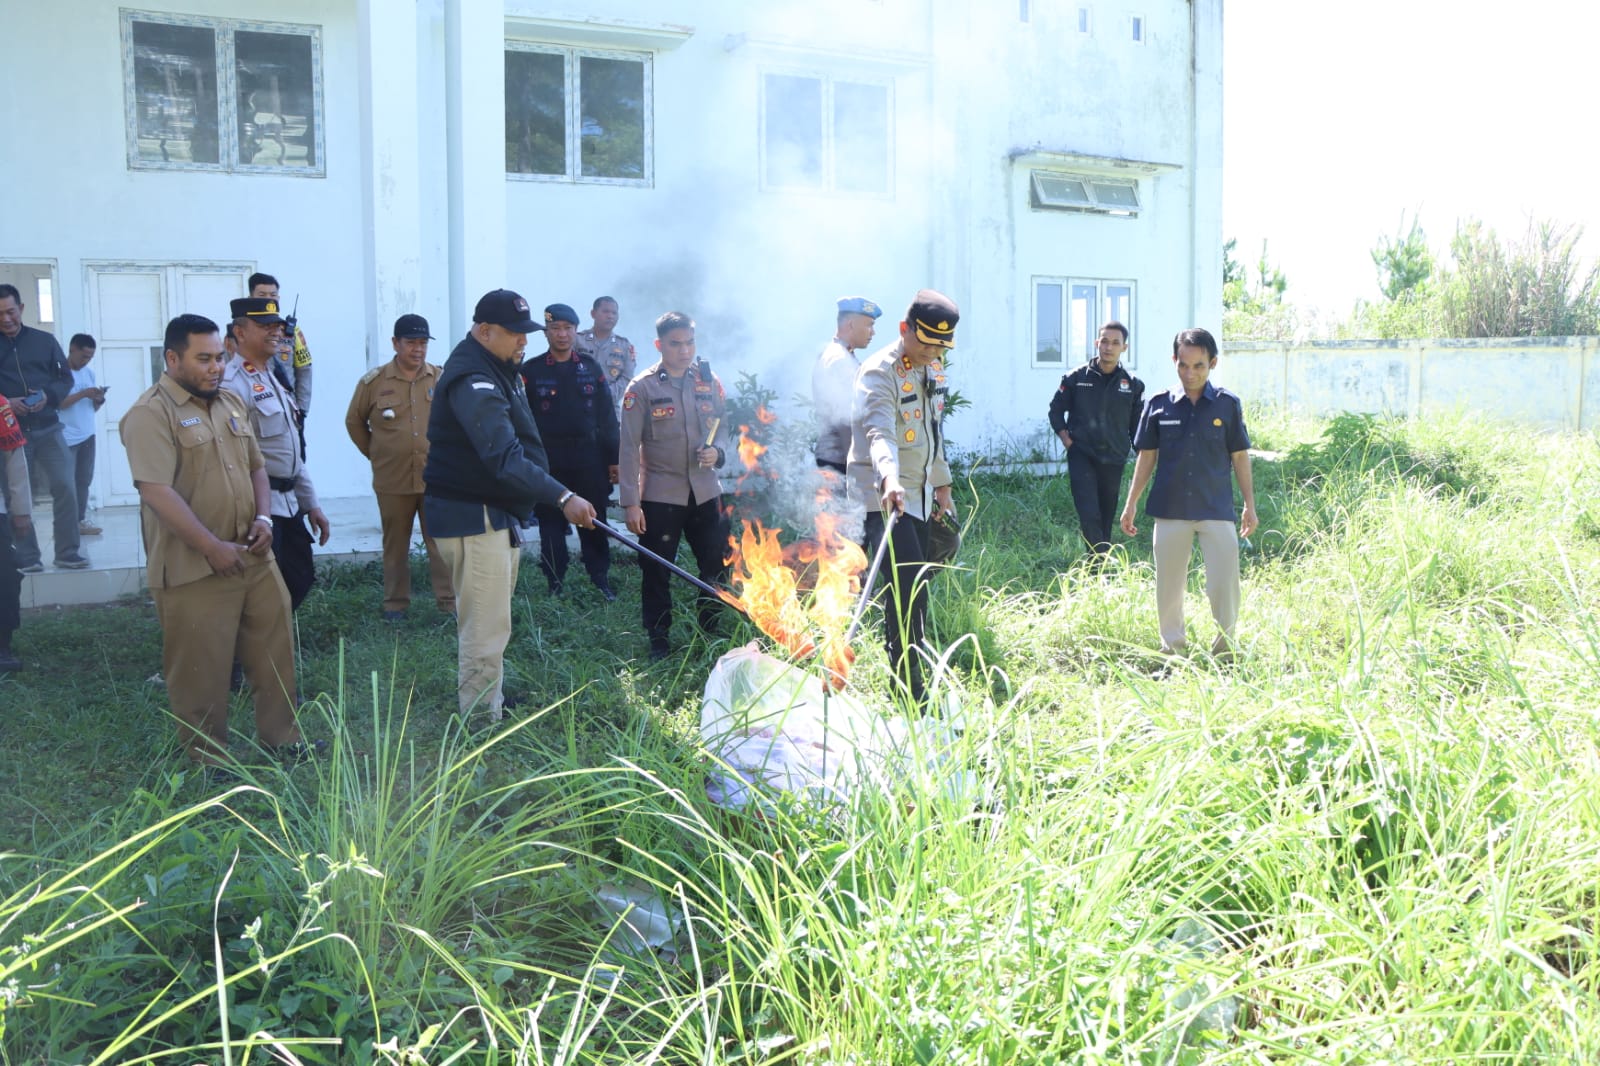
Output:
[{"xmin": 130, "ymin": 22, "xmax": 222, "ymax": 163}]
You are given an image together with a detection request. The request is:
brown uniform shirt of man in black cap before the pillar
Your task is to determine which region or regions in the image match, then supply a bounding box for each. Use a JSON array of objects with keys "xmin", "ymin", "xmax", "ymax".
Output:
[{"xmin": 344, "ymin": 359, "xmax": 438, "ymax": 495}]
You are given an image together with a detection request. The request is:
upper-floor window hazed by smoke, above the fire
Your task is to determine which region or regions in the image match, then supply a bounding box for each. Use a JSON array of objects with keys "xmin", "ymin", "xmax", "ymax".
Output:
[{"xmin": 762, "ymin": 74, "xmax": 893, "ymax": 195}]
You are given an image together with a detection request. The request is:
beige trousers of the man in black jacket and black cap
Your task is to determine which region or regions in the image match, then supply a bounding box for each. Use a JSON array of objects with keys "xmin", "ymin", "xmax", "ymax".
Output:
[{"xmin": 434, "ymin": 511, "xmax": 522, "ymax": 719}]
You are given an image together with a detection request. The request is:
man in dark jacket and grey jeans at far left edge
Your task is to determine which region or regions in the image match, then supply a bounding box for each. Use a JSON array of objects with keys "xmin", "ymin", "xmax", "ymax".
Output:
[{"xmin": 0, "ymin": 278, "xmax": 90, "ymax": 573}]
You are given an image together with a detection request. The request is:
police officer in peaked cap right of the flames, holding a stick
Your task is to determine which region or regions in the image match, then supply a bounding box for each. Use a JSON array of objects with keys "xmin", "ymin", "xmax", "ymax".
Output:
[{"xmin": 850, "ymin": 288, "xmax": 960, "ymax": 706}]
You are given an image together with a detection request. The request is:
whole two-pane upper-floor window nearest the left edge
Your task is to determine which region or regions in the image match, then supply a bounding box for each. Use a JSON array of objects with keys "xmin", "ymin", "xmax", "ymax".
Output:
[{"xmin": 122, "ymin": 11, "xmax": 326, "ymax": 178}]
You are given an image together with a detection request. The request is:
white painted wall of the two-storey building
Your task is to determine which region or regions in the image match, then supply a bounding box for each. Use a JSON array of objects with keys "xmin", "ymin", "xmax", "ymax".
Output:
[{"xmin": 0, "ymin": 0, "xmax": 1221, "ymax": 495}]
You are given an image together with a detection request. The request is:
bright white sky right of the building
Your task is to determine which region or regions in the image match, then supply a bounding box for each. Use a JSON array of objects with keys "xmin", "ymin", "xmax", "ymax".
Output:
[{"xmin": 1222, "ymin": 0, "xmax": 1600, "ymax": 314}]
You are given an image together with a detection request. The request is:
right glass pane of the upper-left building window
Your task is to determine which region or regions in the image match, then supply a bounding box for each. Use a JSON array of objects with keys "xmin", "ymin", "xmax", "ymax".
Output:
[{"xmin": 234, "ymin": 30, "xmax": 317, "ymax": 166}]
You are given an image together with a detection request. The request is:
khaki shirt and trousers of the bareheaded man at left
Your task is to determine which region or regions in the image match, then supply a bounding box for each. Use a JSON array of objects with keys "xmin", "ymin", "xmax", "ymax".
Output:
[{"xmin": 122, "ymin": 375, "xmax": 299, "ymax": 762}]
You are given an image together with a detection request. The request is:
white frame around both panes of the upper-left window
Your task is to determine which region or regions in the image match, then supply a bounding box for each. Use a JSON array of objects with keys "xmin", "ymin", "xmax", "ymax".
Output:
[{"xmin": 118, "ymin": 8, "xmax": 328, "ymax": 178}]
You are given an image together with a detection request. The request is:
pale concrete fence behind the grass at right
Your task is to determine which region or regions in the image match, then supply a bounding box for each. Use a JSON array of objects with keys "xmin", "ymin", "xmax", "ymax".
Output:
[{"xmin": 1216, "ymin": 336, "xmax": 1600, "ymax": 432}]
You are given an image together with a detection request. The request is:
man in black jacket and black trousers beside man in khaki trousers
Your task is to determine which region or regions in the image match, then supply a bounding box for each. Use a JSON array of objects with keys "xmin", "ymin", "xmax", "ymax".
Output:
[{"xmin": 1050, "ymin": 322, "xmax": 1144, "ymax": 555}]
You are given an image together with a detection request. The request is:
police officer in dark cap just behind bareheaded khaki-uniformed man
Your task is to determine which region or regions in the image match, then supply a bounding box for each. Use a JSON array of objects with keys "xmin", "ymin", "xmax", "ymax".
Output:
[{"xmin": 222, "ymin": 296, "xmax": 331, "ymax": 610}]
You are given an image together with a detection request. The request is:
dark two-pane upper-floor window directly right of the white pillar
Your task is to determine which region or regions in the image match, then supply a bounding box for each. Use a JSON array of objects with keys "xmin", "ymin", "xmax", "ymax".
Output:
[{"xmin": 506, "ymin": 42, "xmax": 654, "ymax": 186}]
